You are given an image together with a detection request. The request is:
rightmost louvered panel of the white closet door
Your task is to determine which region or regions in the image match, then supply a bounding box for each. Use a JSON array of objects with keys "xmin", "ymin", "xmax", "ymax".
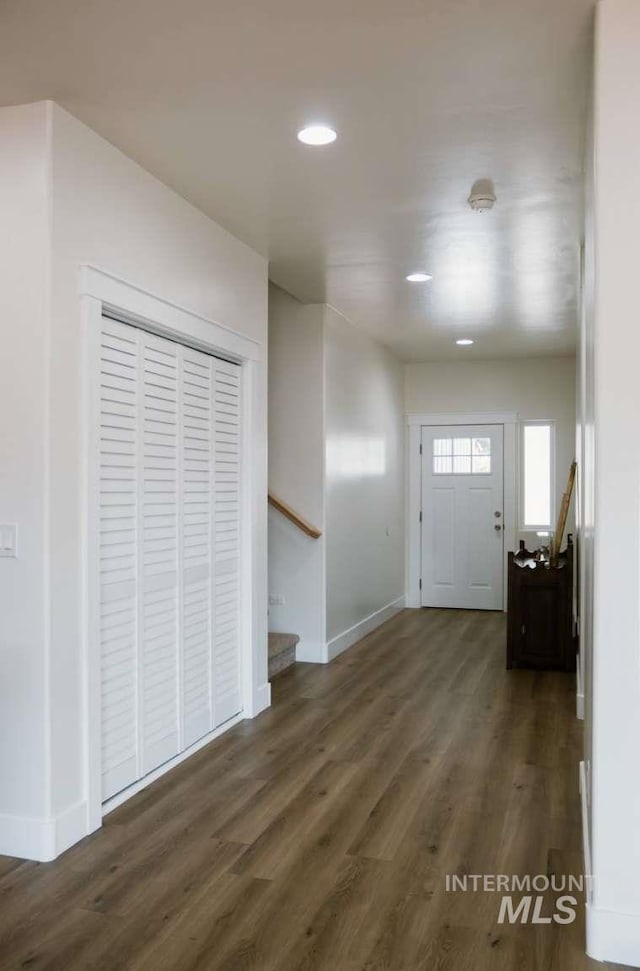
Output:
[{"xmin": 213, "ymin": 359, "xmax": 242, "ymax": 725}]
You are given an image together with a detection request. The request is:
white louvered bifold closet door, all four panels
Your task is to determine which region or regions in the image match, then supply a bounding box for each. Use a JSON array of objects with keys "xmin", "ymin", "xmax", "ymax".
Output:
[{"xmin": 97, "ymin": 318, "xmax": 242, "ymax": 799}]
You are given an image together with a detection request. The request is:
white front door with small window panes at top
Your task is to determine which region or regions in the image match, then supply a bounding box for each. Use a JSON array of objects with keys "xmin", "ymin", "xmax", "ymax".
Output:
[{"xmin": 422, "ymin": 425, "xmax": 504, "ymax": 610}]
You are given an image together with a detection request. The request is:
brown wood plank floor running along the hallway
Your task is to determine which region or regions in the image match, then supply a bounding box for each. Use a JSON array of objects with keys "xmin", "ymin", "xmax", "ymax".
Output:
[{"xmin": 0, "ymin": 610, "xmax": 628, "ymax": 971}]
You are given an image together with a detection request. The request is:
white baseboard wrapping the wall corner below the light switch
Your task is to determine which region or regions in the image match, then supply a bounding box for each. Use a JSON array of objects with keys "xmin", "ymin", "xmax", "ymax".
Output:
[{"xmin": 0, "ymin": 802, "xmax": 87, "ymax": 863}]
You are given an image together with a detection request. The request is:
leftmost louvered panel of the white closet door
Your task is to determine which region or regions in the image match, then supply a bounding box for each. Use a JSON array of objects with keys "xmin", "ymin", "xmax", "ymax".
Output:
[{"xmin": 98, "ymin": 320, "xmax": 138, "ymax": 798}]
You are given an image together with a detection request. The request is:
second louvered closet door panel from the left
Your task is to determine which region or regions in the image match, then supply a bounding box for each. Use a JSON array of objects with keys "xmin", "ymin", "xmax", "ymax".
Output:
[{"xmin": 138, "ymin": 333, "xmax": 180, "ymax": 774}]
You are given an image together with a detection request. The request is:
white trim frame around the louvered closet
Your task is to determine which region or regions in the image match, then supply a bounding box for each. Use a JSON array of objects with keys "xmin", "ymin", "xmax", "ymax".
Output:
[{"xmin": 79, "ymin": 265, "xmax": 271, "ymax": 833}]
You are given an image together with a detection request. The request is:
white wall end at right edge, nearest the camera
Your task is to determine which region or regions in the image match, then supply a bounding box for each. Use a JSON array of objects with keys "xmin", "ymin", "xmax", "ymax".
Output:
[{"xmin": 586, "ymin": 0, "xmax": 640, "ymax": 965}]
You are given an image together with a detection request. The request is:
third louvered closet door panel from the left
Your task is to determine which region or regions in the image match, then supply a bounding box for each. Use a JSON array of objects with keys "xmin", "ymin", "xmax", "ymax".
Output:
[{"xmin": 181, "ymin": 347, "xmax": 213, "ymax": 747}]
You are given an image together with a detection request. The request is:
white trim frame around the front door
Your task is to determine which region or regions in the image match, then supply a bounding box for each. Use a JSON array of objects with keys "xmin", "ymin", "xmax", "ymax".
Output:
[{"xmin": 406, "ymin": 411, "xmax": 518, "ymax": 610}]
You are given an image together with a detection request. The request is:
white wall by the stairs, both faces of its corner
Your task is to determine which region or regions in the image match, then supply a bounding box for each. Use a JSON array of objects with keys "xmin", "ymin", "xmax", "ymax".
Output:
[{"xmin": 269, "ymin": 294, "xmax": 404, "ymax": 662}]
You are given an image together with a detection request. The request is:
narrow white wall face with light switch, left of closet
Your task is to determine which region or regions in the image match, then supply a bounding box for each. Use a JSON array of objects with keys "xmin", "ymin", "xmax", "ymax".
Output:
[{"xmin": 0, "ymin": 104, "xmax": 49, "ymax": 828}]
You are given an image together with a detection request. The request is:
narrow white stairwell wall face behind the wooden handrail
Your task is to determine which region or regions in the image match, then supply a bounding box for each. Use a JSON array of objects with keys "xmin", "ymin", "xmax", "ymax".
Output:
[{"xmin": 269, "ymin": 284, "xmax": 326, "ymax": 661}]
